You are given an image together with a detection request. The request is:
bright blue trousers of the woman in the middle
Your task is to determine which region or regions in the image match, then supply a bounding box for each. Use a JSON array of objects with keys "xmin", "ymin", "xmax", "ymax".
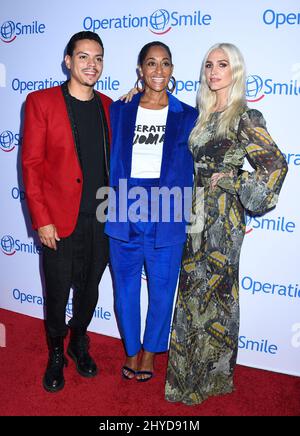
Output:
[{"xmin": 109, "ymin": 179, "xmax": 184, "ymax": 356}]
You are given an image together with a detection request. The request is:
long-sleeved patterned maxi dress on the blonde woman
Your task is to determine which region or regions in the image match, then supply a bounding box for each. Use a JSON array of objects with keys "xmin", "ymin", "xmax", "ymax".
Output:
[{"xmin": 165, "ymin": 109, "xmax": 287, "ymax": 404}]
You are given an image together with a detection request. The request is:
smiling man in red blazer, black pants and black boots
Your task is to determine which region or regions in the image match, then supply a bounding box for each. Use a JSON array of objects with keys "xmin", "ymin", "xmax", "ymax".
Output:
[{"xmin": 22, "ymin": 31, "xmax": 112, "ymax": 392}]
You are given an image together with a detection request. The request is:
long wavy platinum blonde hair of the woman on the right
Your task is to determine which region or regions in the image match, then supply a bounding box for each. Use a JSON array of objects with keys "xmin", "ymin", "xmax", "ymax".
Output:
[{"xmin": 190, "ymin": 43, "xmax": 247, "ymax": 143}]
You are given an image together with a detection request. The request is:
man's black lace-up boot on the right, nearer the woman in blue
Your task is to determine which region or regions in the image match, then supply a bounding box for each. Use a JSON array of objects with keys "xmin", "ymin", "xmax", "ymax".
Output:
[{"xmin": 68, "ymin": 330, "xmax": 98, "ymax": 377}]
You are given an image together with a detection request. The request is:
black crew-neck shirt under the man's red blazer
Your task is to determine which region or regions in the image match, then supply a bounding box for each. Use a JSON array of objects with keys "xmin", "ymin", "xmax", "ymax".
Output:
[{"xmin": 71, "ymin": 96, "xmax": 105, "ymax": 214}]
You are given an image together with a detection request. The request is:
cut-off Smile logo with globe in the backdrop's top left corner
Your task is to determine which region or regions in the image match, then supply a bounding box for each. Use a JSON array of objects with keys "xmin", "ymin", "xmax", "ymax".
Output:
[{"xmin": 0, "ymin": 20, "xmax": 46, "ymax": 44}]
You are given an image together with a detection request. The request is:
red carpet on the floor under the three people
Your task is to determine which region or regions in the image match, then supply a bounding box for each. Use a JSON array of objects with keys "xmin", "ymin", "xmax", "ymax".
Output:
[{"xmin": 0, "ymin": 309, "xmax": 300, "ymax": 417}]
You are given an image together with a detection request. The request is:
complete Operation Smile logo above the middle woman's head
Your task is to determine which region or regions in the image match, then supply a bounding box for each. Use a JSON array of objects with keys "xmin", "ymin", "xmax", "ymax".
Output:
[{"xmin": 83, "ymin": 9, "xmax": 212, "ymax": 35}]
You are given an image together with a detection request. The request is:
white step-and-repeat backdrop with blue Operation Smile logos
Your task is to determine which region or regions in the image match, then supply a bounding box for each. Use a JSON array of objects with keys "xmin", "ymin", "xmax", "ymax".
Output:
[{"xmin": 0, "ymin": 0, "xmax": 300, "ymax": 376}]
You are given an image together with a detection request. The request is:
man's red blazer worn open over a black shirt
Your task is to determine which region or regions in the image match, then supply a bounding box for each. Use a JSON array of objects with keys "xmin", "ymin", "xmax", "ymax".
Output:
[{"xmin": 22, "ymin": 86, "xmax": 112, "ymax": 237}]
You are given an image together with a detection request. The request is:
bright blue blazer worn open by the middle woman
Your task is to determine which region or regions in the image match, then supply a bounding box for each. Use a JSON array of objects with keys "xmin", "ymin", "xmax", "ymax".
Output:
[{"xmin": 105, "ymin": 94, "xmax": 198, "ymax": 247}]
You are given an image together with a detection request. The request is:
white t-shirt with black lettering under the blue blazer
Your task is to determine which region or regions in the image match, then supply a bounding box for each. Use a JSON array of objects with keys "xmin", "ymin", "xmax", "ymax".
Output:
[{"xmin": 131, "ymin": 106, "xmax": 168, "ymax": 179}]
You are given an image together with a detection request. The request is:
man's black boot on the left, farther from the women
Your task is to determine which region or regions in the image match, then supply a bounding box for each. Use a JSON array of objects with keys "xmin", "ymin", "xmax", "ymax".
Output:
[{"xmin": 43, "ymin": 336, "xmax": 68, "ymax": 392}]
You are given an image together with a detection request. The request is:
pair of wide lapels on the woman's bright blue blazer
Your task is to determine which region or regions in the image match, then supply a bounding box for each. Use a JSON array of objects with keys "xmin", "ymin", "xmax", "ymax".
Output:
[{"xmin": 121, "ymin": 93, "xmax": 183, "ymax": 182}]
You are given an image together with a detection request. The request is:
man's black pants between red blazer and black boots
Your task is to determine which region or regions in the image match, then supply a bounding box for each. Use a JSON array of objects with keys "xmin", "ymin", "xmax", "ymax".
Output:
[{"xmin": 43, "ymin": 214, "xmax": 108, "ymax": 337}]
